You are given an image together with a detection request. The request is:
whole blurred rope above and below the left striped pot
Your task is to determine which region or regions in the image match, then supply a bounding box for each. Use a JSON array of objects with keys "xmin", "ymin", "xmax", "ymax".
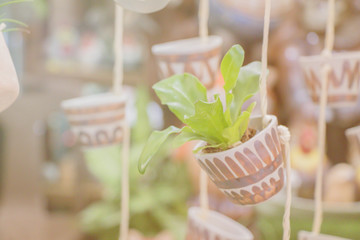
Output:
[{"xmin": 113, "ymin": 3, "xmax": 130, "ymax": 240}]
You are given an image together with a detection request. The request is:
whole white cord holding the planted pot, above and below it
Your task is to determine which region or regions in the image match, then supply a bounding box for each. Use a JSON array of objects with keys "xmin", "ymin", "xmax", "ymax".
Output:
[{"xmin": 260, "ymin": 0, "xmax": 291, "ymax": 240}]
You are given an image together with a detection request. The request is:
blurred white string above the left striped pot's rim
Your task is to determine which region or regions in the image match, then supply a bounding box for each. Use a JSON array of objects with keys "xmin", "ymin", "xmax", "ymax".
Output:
[{"xmin": 113, "ymin": 3, "xmax": 124, "ymax": 95}]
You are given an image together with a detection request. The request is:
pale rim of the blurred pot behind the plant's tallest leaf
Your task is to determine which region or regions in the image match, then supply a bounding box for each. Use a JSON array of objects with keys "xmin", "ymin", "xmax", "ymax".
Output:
[{"xmin": 151, "ymin": 35, "xmax": 223, "ymax": 55}]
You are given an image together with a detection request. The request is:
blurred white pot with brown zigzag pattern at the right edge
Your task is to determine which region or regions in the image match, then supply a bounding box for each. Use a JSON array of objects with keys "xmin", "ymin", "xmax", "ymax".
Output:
[{"xmin": 300, "ymin": 52, "xmax": 360, "ymax": 108}]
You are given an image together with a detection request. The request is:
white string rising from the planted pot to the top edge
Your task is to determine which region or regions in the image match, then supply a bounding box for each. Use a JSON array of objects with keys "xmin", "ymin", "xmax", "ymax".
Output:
[{"xmin": 260, "ymin": 0, "xmax": 271, "ymax": 127}]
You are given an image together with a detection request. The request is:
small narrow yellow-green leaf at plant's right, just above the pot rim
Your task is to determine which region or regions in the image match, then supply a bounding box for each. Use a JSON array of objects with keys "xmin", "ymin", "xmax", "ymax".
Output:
[{"xmin": 223, "ymin": 111, "xmax": 250, "ymax": 145}]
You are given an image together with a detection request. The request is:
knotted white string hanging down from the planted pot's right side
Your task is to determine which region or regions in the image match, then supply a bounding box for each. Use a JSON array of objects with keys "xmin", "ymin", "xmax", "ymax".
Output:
[{"xmin": 278, "ymin": 126, "xmax": 292, "ymax": 240}]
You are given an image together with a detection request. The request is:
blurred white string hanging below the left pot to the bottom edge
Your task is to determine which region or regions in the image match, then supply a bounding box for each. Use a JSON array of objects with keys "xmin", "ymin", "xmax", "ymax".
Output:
[{"xmin": 120, "ymin": 120, "xmax": 130, "ymax": 240}]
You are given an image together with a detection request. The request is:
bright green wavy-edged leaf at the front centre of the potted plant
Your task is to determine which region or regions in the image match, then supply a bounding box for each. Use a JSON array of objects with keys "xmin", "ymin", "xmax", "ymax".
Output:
[{"xmin": 185, "ymin": 98, "xmax": 227, "ymax": 143}]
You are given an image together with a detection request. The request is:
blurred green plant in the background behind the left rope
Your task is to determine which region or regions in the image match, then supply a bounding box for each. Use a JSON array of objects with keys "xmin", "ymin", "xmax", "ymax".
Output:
[{"xmin": 81, "ymin": 86, "xmax": 191, "ymax": 240}]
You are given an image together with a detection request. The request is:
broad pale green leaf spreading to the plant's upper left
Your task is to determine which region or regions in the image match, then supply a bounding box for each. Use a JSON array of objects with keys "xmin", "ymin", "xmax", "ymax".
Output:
[{"xmin": 153, "ymin": 73, "xmax": 207, "ymax": 122}]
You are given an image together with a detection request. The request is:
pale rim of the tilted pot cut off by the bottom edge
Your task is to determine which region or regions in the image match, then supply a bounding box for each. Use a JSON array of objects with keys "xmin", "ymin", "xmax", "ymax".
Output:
[{"xmin": 188, "ymin": 207, "xmax": 254, "ymax": 240}]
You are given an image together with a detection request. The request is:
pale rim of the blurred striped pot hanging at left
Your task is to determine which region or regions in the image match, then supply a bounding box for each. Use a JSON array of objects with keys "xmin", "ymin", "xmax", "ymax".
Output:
[{"xmin": 61, "ymin": 92, "xmax": 127, "ymax": 109}]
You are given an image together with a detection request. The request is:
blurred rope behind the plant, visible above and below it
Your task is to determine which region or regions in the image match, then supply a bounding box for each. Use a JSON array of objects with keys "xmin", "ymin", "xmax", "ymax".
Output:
[{"xmin": 198, "ymin": 0, "xmax": 209, "ymax": 218}]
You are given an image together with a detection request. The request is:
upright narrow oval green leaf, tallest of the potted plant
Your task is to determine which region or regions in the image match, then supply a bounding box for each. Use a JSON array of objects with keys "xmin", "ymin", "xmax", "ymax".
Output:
[{"xmin": 221, "ymin": 44, "xmax": 245, "ymax": 93}]
